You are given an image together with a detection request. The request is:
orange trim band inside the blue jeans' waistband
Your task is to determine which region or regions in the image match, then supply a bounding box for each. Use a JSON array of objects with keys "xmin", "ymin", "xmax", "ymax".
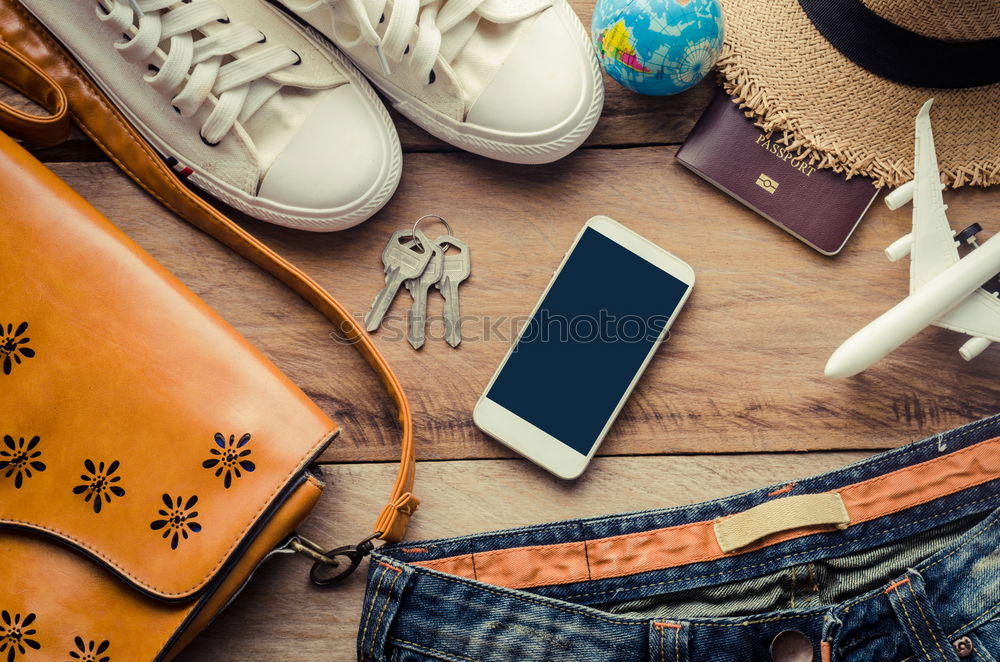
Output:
[{"xmin": 414, "ymin": 437, "xmax": 1000, "ymax": 588}]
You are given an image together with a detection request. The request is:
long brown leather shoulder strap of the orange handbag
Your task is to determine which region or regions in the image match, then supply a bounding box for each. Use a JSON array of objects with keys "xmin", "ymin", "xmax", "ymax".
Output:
[{"xmin": 0, "ymin": 18, "xmax": 420, "ymax": 548}]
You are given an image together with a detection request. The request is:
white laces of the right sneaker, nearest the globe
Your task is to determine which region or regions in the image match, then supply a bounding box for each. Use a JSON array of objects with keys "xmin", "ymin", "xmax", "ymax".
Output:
[{"xmin": 292, "ymin": 0, "xmax": 485, "ymax": 83}]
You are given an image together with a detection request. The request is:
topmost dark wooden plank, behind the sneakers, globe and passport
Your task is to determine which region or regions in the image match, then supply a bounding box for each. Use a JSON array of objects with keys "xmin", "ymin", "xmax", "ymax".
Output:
[{"xmin": 0, "ymin": 0, "xmax": 712, "ymax": 157}]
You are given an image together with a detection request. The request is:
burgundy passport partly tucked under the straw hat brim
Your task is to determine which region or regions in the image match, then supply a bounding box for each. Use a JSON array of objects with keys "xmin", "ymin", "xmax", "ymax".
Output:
[{"xmin": 677, "ymin": 89, "xmax": 878, "ymax": 255}]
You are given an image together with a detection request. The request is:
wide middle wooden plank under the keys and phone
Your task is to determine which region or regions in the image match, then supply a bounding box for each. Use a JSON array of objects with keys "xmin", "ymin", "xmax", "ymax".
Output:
[{"xmin": 45, "ymin": 158, "xmax": 1000, "ymax": 461}]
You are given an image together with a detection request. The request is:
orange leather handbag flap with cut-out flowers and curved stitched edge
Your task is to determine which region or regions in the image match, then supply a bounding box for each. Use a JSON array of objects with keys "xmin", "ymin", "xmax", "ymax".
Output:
[{"xmin": 0, "ymin": 134, "xmax": 336, "ymax": 600}]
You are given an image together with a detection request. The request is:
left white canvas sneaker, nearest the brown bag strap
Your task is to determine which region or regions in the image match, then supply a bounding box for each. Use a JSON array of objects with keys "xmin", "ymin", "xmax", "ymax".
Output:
[{"xmin": 21, "ymin": 0, "xmax": 402, "ymax": 231}]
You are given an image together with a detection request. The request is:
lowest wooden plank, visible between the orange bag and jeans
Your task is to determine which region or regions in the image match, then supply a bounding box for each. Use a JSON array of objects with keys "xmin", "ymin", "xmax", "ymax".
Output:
[{"xmin": 177, "ymin": 453, "xmax": 864, "ymax": 662}]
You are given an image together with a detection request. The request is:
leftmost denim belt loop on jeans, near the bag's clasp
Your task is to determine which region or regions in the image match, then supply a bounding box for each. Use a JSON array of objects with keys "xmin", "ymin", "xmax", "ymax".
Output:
[{"xmin": 358, "ymin": 556, "xmax": 413, "ymax": 662}]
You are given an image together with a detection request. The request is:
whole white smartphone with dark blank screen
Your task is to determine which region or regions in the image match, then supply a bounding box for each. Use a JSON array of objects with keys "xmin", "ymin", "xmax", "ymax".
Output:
[{"xmin": 472, "ymin": 216, "xmax": 694, "ymax": 478}]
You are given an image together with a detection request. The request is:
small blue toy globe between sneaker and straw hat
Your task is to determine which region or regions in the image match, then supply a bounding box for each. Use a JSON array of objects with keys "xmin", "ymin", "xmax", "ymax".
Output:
[{"xmin": 591, "ymin": 0, "xmax": 725, "ymax": 96}]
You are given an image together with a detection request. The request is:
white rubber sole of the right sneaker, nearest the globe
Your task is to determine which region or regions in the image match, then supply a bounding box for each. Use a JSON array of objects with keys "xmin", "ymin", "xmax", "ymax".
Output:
[{"xmin": 271, "ymin": 0, "xmax": 604, "ymax": 164}]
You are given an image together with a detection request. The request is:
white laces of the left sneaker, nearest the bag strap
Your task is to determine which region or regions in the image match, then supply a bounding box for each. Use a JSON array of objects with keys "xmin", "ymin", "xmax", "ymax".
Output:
[{"xmin": 97, "ymin": 0, "xmax": 301, "ymax": 145}]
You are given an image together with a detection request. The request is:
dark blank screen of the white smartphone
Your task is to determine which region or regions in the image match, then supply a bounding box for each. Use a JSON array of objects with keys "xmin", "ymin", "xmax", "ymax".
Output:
[{"xmin": 486, "ymin": 228, "xmax": 688, "ymax": 455}]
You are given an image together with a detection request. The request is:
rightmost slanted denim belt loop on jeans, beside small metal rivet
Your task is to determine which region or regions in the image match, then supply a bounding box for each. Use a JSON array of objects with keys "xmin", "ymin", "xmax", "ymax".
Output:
[{"xmin": 885, "ymin": 570, "xmax": 959, "ymax": 662}]
